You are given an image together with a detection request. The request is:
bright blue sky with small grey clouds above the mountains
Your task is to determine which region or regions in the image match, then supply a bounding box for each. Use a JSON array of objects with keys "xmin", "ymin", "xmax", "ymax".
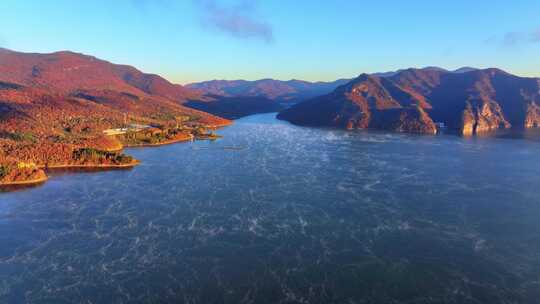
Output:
[{"xmin": 0, "ymin": 0, "xmax": 540, "ymax": 83}]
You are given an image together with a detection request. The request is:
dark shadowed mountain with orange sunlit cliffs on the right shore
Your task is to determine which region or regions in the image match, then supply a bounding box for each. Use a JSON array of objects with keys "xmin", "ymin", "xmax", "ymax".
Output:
[{"xmin": 278, "ymin": 68, "xmax": 540, "ymax": 135}]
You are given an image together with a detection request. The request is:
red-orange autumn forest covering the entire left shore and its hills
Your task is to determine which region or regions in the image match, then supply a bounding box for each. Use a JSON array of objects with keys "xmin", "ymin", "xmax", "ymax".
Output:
[{"xmin": 0, "ymin": 49, "xmax": 231, "ymax": 184}]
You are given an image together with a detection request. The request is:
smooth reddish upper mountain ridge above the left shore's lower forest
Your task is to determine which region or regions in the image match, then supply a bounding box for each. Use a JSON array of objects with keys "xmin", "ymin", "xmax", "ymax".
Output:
[{"xmin": 0, "ymin": 49, "xmax": 198, "ymax": 101}]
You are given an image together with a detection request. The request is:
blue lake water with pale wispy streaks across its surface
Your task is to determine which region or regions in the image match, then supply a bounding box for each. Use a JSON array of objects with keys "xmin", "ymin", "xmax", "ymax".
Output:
[{"xmin": 0, "ymin": 114, "xmax": 540, "ymax": 303}]
